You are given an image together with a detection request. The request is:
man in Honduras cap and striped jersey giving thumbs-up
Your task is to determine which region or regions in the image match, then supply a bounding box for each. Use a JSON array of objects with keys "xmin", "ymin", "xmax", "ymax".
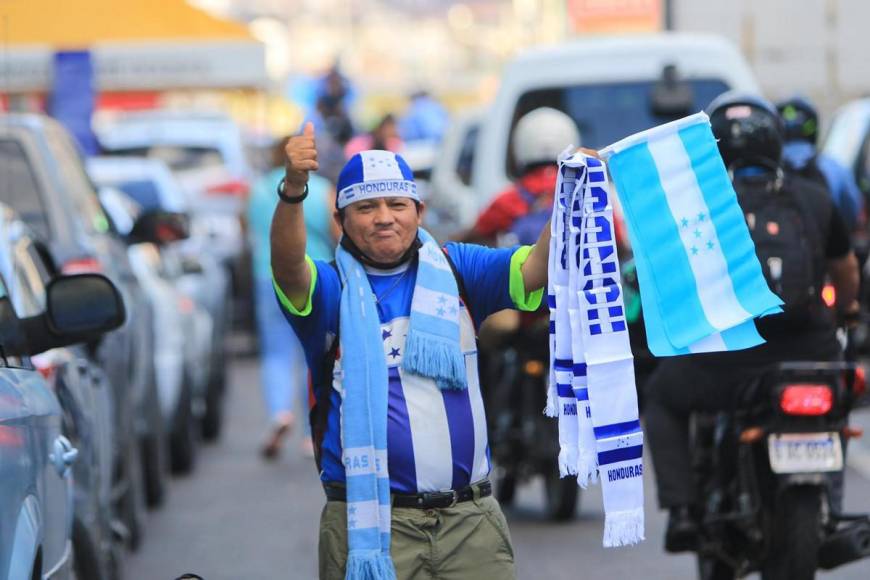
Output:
[{"xmin": 271, "ymin": 124, "xmax": 549, "ymax": 579}]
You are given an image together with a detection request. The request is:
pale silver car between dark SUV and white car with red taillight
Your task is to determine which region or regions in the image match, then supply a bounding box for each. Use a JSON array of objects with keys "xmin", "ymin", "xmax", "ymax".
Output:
[{"xmin": 88, "ymin": 157, "xmax": 232, "ymax": 440}]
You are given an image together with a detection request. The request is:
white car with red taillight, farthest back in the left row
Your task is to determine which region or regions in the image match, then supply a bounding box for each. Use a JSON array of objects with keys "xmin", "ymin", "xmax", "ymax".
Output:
[{"xmin": 95, "ymin": 110, "xmax": 253, "ymax": 331}]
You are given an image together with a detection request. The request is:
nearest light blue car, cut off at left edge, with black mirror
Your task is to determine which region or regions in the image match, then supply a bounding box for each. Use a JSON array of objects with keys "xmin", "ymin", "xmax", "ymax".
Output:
[{"xmin": 0, "ymin": 249, "xmax": 124, "ymax": 580}]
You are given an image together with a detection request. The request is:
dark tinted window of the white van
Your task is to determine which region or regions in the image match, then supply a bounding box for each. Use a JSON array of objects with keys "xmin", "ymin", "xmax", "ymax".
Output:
[{"xmin": 507, "ymin": 79, "xmax": 729, "ymax": 177}]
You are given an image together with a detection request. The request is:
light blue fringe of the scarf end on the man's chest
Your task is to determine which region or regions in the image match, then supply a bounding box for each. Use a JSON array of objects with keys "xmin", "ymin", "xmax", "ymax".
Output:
[{"xmin": 402, "ymin": 329, "xmax": 468, "ymax": 390}]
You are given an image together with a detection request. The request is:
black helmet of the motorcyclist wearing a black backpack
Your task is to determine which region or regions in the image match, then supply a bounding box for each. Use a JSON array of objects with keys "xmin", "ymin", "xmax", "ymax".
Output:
[{"xmin": 707, "ymin": 92, "xmax": 784, "ymax": 170}]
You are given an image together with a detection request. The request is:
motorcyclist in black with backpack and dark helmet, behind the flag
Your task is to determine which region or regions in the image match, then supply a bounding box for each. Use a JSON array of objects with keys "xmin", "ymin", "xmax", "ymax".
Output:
[{"xmin": 645, "ymin": 93, "xmax": 858, "ymax": 552}]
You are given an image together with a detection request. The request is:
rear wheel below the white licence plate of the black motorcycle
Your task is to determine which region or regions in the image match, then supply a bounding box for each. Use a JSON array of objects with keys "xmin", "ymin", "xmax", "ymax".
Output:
[{"xmin": 761, "ymin": 487, "xmax": 822, "ymax": 580}]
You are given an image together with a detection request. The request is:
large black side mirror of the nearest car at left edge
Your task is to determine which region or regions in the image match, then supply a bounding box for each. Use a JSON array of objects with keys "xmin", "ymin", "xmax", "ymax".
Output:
[{"xmin": 16, "ymin": 274, "xmax": 126, "ymax": 355}]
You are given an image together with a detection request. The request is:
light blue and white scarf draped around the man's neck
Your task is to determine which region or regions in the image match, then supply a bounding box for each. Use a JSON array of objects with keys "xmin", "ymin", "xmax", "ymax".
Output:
[{"xmin": 336, "ymin": 228, "xmax": 467, "ymax": 580}]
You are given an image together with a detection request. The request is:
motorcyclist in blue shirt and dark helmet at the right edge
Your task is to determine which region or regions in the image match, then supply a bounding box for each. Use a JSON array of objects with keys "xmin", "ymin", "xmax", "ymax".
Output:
[{"xmin": 776, "ymin": 96, "xmax": 864, "ymax": 231}]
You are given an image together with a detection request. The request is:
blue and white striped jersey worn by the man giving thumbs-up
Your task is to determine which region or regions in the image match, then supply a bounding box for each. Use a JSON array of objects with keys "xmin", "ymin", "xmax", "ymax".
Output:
[{"xmin": 279, "ymin": 243, "xmax": 534, "ymax": 493}]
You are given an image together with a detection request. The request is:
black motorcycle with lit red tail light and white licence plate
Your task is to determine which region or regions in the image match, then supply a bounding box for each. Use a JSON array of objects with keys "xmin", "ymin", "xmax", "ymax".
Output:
[{"xmin": 691, "ymin": 363, "xmax": 870, "ymax": 580}]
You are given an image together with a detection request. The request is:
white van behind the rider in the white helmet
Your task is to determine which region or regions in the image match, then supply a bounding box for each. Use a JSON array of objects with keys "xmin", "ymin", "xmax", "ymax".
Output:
[{"xmin": 432, "ymin": 33, "xmax": 759, "ymax": 233}]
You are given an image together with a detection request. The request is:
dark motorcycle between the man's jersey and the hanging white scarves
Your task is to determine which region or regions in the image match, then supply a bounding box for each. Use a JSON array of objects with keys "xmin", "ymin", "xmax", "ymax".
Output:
[{"xmin": 481, "ymin": 315, "xmax": 580, "ymax": 521}]
